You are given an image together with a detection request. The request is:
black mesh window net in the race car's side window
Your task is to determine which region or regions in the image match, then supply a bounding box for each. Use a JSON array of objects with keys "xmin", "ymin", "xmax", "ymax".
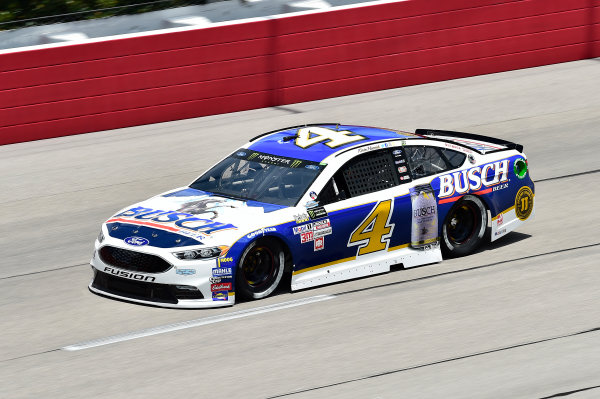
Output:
[{"xmin": 342, "ymin": 150, "xmax": 398, "ymax": 197}]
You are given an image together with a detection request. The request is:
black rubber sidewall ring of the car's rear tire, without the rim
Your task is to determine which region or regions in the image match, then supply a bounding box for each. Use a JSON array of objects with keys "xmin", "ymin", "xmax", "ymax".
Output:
[{"xmin": 441, "ymin": 195, "xmax": 487, "ymax": 257}]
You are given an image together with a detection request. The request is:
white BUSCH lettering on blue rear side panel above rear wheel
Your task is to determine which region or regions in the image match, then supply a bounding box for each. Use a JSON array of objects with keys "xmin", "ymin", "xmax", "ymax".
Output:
[{"xmin": 439, "ymin": 159, "xmax": 509, "ymax": 198}]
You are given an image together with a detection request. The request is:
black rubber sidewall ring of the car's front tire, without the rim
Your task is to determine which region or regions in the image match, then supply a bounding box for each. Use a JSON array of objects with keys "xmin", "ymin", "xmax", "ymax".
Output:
[{"xmin": 235, "ymin": 238, "xmax": 285, "ymax": 299}]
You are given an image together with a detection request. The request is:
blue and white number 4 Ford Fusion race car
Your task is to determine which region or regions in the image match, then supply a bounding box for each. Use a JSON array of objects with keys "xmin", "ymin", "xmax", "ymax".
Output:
[{"xmin": 89, "ymin": 123, "xmax": 534, "ymax": 308}]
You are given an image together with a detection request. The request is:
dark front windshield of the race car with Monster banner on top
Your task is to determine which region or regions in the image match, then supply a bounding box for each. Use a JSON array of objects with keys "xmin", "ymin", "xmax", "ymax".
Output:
[{"xmin": 190, "ymin": 149, "xmax": 324, "ymax": 206}]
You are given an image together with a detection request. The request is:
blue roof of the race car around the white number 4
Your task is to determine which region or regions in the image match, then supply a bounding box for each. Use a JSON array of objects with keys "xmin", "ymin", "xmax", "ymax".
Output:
[{"xmin": 247, "ymin": 123, "xmax": 421, "ymax": 162}]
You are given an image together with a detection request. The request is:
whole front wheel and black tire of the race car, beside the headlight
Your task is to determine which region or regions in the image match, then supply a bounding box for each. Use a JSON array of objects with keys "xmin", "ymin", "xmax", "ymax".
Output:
[{"xmin": 235, "ymin": 238, "xmax": 285, "ymax": 299}]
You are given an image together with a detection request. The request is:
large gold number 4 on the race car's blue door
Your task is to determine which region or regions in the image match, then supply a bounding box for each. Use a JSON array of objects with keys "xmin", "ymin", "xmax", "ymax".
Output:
[{"xmin": 348, "ymin": 200, "xmax": 394, "ymax": 256}]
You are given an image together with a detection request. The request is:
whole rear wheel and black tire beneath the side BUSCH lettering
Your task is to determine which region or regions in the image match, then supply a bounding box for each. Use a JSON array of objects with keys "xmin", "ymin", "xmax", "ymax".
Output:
[{"xmin": 442, "ymin": 195, "xmax": 487, "ymax": 257}]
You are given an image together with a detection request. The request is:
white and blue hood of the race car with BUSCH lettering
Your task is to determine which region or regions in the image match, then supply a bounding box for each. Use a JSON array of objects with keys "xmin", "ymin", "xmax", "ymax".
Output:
[{"xmin": 106, "ymin": 187, "xmax": 289, "ymax": 248}]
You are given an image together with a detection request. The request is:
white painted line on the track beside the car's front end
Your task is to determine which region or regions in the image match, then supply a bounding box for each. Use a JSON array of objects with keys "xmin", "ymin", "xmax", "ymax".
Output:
[{"xmin": 61, "ymin": 295, "xmax": 335, "ymax": 351}]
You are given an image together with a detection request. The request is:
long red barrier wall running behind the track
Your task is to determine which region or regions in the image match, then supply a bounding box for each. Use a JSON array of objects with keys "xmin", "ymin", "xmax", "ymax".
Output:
[{"xmin": 0, "ymin": 0, "xmax": 600, "ymax": 144}]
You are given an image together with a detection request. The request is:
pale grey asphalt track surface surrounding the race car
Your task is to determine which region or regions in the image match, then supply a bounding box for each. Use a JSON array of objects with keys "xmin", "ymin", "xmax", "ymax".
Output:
[{"xmin": 0, "ymin": 59, "xmax": 600, "ymax": 399}]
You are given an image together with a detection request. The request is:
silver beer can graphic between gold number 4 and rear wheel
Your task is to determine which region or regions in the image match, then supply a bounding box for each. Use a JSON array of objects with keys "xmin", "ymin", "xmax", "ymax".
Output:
[{"xmin": 410, "ymin": 184, "xmax": 438, "ymax": 248}]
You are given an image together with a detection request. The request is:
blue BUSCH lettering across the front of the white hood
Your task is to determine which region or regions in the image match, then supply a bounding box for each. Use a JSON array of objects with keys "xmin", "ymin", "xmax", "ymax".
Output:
[{"xmin": 106, "ymin": 206, "xmax": 237, "ymax": 235}]
